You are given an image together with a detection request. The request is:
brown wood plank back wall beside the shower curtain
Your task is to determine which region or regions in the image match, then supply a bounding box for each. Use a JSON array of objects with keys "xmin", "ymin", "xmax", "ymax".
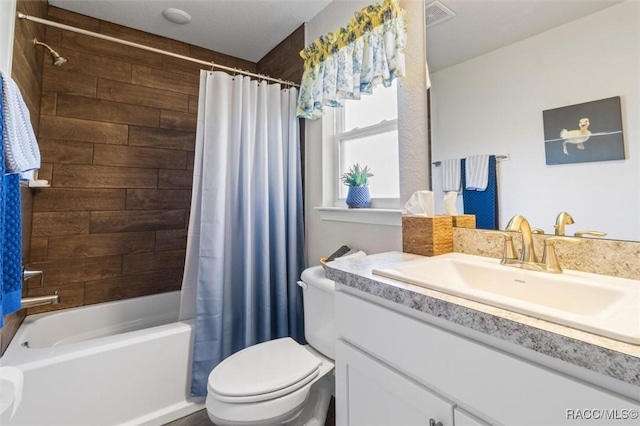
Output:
[{"xmin": 29, "ymin": 7, "xmax": 257, "ymax": 313}]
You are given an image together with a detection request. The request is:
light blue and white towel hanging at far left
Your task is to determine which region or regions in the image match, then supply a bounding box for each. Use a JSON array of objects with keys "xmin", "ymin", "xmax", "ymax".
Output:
[{"xmin": 0, "ymin": 70, "xmax": 40, "ymax": 173}]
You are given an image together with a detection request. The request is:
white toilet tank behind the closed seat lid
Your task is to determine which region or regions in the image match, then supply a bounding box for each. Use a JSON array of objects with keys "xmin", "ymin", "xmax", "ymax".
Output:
[{"xmin": 298, "ymin": 266, "xmax": 336, "ymax": 359}]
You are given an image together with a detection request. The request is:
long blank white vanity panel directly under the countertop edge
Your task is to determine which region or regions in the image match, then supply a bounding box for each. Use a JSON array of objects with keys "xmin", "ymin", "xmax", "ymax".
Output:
[{"xmin": 336, "ymin": 291, "xmax": 640, "ymax": 426}]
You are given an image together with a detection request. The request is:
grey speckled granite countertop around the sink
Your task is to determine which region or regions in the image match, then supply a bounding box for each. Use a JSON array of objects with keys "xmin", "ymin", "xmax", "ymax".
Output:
[{"xmin": 326, "ymin": 252, "xmax": 640, "ymax": 386}]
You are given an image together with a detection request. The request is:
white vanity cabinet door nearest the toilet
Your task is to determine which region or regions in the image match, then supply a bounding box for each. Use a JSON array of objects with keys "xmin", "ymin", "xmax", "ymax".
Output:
[{"xmin": 336, "ymin": 341, "xmax": 454, "ymax": 426}]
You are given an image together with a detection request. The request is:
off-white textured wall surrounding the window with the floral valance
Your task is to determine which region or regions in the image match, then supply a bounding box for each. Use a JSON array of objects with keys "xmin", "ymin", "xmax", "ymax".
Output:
[{"xmin": 305, "ymin": 0, "xmax": 430, "ymax": 266}]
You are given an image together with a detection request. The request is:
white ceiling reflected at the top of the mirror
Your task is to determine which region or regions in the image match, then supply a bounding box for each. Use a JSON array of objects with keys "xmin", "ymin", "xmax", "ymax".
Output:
[{"xmin": 426, "ymin": 0, "xmax": 624, "ymax": 72}]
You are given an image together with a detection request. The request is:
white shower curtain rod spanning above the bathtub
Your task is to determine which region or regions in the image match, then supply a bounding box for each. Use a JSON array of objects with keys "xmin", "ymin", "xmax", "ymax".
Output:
[{"xmin": 17, "ymin": 12, "xmax": 300, "ymax": 87}]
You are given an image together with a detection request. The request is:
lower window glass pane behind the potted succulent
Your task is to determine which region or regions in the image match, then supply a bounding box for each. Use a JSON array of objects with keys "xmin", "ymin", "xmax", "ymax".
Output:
[{"xmin": 340, "ymin": 130, "xmax": 400, "ymax": 198}]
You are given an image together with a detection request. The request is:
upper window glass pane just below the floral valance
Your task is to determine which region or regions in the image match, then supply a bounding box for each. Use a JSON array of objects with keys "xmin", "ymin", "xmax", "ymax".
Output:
[{"xmin": 343, "ymin": 80, "xmax": 398, "ymax": 132}]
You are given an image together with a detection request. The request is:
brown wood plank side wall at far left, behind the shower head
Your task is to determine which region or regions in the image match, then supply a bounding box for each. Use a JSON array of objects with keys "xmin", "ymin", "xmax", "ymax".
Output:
[{"xmin": 0, "ymin": 0, "xmax": 48, "ymax": 355}]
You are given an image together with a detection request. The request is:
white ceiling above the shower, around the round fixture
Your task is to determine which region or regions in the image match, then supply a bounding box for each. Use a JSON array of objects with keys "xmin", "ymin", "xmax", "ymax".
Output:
[{"xmin": 49, "ymin": 0, "xmax": 331, "ymax": 62}]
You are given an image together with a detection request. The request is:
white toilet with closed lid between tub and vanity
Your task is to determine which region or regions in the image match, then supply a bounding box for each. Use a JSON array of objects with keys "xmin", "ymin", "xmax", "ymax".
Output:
[{"xmin": 206, "ymin": 266, "xmax": 336, "ymax": 426}]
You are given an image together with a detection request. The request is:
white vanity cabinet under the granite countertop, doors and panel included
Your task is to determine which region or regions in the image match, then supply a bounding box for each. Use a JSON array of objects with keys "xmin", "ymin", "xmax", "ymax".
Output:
[{"xmin": 336, "ymin": 285, "xmax": 640, "ymax": 426}]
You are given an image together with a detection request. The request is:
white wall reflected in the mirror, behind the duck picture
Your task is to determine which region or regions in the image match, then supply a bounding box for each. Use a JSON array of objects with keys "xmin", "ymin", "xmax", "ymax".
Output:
[{"xmin": 431, "ymin": 0, "xmax": 640, "ymax": 240}]
